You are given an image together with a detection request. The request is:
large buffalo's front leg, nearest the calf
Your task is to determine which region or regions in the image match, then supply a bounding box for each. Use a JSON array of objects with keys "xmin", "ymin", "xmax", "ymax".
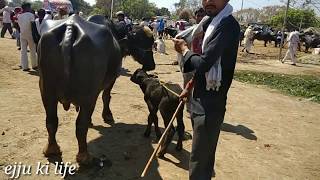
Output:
[{"xmin": 102, "ymin": 80, "xmax": 116, "ymax": 124}]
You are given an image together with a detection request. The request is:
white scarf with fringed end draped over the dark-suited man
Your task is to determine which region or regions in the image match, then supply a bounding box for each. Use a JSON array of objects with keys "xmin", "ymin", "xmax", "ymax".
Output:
[{"xmin": 176, "ymin": 3, "xmax": 233, "ymax": 91}]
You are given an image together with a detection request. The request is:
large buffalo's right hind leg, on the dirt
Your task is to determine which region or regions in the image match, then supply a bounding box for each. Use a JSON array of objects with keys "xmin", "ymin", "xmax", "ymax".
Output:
[{"xmin": 76, "ymin": 101, "xmax": 95, "ymax": 165}]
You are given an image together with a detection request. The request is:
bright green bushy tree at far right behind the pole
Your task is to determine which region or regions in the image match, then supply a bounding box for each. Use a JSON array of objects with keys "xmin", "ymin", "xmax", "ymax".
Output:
[{"xmin": 269, "ymin": 9, "xmax": 319, "ymax": 31}]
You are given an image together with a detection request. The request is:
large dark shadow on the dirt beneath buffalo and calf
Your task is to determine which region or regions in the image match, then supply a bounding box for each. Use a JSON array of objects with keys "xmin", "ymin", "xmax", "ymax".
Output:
[{"xmin": 65, "ymin": 123, "xmax": 189, "ymax": 180}]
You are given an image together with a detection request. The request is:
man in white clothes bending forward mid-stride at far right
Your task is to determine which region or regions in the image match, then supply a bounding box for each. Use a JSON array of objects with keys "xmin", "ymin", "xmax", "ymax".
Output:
[{"xmin": 281, "ymin": 30, "xmax": 300, "ymax": 66}]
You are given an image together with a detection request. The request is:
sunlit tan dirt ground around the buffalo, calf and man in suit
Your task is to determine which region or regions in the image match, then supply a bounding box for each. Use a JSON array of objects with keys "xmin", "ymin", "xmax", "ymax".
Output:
[{"xmin": 0, "ymin": 33, "xmax": 320, "ymax": 180}]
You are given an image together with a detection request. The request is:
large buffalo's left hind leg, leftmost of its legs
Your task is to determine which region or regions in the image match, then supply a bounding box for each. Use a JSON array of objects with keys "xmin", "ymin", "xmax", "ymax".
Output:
[{"xmin": 41, "ymin": 88, "xmax": 61, "ymax": 157}]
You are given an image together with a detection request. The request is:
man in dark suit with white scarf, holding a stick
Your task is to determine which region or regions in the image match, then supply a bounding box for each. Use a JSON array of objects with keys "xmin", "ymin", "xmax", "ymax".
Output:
[{"xmin": 173, "ymin": 0, "xmax": 240, "ymax": 180}]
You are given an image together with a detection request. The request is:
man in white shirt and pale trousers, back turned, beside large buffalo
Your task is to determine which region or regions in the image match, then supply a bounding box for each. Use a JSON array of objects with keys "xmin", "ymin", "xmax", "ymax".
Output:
[{"xmin": 18, "ymin": 2, "xmax": 38, "ymax": 71}]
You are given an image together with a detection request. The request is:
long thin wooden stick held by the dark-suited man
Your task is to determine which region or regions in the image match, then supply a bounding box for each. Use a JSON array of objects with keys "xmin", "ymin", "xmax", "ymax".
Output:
[{"xmin": 141, "ymin": 101, "xmax": 184, "ymax": 177}]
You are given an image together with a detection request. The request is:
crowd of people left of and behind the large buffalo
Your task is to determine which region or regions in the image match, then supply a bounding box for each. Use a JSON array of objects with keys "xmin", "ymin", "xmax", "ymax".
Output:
[{"xmin": 0, "ymin": 2, "xmax": 81, "ymax": 71}]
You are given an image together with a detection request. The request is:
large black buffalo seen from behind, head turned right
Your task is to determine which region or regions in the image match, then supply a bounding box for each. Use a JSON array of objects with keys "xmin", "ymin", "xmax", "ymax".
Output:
[{"xmin": 38, "ymin": 15, "xmax": 155, "ymax": 164}]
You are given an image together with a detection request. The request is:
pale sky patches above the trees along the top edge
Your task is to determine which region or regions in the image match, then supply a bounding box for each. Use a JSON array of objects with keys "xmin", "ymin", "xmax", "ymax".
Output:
[{"xmin": 85, "ymin": 0, "xmax": 283, "ymax": 11}]
